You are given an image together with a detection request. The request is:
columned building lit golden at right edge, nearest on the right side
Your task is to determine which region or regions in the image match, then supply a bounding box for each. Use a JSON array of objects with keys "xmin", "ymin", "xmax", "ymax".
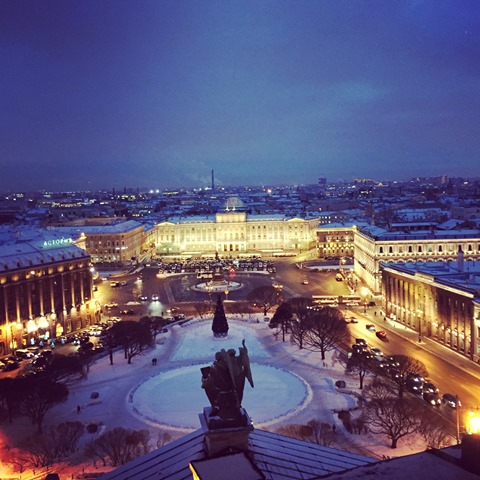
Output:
[{"xmin": 382, "ymin": 260, "xmax": 480, "ymax": 362}]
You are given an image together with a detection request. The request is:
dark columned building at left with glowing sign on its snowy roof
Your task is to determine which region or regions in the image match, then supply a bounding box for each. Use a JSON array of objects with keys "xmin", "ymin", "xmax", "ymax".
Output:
[{"xmin": 0, "ymin": 238, "xmax": 94, "ymax": 354}]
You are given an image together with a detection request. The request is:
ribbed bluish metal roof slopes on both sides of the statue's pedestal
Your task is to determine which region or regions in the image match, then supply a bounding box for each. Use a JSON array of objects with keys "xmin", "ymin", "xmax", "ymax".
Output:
[{"xmin": 101, "ymin": 429, "xmax": 376, "ymax": 480}]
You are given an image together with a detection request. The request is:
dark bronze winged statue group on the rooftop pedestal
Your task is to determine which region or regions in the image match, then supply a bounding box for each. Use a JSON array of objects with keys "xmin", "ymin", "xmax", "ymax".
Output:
[{"xmin": 201, "ymin": 340, "xmax": 253, "ymax": 426}]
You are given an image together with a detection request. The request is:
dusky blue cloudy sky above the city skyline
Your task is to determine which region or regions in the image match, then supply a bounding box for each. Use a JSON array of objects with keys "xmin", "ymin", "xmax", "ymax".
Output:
[{"xmin": 0, "ymin": 0, "xmax": 480, "ymax": 190}]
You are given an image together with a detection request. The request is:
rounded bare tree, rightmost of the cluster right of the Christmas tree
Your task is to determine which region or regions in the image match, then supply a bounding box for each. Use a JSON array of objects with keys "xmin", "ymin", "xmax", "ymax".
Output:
[{"xmin": 304, "ymin": 307, "xmax": 350, "ymax": 360}]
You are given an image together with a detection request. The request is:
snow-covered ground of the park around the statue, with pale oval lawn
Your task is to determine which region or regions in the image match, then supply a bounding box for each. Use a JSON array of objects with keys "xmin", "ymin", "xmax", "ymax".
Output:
[{"xmin": 0, "ymin": 316, "xmax": 444, "ymax": 479}]
